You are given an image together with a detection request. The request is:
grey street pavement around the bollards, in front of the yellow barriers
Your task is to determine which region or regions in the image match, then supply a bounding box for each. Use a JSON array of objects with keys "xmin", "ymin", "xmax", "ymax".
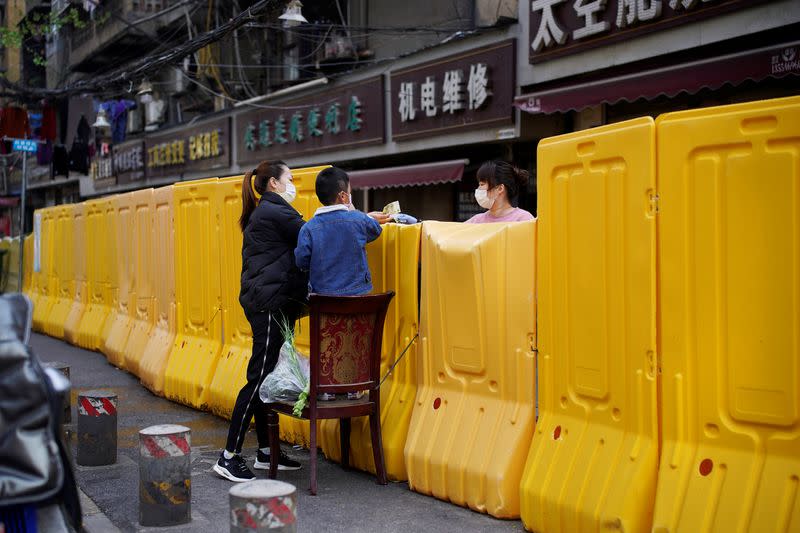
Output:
[{"xmin": 31, "ymin": 334, "xmax": 524, "ymax": 533}]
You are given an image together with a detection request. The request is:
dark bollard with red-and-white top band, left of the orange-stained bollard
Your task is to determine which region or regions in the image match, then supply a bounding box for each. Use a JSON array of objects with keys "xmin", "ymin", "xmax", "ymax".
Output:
[{"xmin": 78, "ymin": 390, "xmax": 117, "ymax": 466}]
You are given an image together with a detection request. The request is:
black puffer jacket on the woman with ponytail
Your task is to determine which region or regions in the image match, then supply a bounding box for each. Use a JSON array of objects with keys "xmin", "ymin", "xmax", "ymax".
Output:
[{"xmin": 239, "ymin": 192, "xmax": 308, "ymax": 314}]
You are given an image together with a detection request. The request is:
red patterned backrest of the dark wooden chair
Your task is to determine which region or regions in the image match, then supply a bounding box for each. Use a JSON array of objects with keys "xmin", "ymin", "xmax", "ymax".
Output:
[{"xmin": 309, "ymin": 291, "xmax": 394, "ymax": 395}]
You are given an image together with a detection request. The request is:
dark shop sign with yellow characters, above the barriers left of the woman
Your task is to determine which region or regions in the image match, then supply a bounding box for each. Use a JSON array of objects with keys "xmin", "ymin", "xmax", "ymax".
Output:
[{"xmin": 144, "ymin": 117, "xmax": 231, "ymax": 178}]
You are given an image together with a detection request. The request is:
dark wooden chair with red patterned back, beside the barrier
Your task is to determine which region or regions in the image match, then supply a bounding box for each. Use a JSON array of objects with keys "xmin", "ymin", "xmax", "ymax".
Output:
[{"xmin": 266, "ymin": 291, "xmax": 394, "ymax": 494}]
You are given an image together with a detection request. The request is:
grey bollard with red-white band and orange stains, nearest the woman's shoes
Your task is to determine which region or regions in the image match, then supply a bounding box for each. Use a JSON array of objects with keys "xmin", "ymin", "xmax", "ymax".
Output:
[{"xmin": 139, "ymin": 424, "xmax": 192, "ymax": 527}]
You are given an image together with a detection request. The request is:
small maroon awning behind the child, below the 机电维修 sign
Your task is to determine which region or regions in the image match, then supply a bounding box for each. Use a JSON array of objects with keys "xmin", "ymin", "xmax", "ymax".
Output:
[{"xmin": 348, "ymin": 159, "xmax": 469, "ymax": 189}]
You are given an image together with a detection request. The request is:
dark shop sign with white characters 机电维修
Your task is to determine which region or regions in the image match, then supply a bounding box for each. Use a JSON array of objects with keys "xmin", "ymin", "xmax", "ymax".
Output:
[{"xmin": 391, "ymin": 40, "xmax": 515, "ymax": 141}]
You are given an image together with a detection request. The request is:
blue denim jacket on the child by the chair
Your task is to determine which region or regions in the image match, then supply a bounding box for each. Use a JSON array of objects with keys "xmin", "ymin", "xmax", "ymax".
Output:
[{"xmin": 294, "ymin": 205, "xmax": 381, "ymax": 296}]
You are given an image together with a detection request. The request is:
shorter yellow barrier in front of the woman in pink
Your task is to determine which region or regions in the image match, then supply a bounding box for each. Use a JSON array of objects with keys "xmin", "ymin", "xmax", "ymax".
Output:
[{"xmin": 405, "ymin": 221, "xmax": 536, "ymax": 518}]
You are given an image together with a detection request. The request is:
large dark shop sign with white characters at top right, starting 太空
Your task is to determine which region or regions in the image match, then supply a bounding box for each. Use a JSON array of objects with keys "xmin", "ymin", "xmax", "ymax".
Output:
[{"xmin": 528, "ymin": 0, "xmax": 769, "ymax": 64}]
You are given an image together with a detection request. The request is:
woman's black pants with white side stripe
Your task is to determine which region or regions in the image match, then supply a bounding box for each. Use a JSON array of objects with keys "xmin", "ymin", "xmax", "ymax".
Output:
[{"xmin": 225, "ymin": 305, "xmax": 300, "ymax": 453}]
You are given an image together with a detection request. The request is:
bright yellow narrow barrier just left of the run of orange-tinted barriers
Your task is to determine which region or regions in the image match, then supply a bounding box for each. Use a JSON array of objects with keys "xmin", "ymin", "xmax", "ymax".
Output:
[{"xmin": 77, "ymin": 196, "xmax": 117, "ymax": 350}]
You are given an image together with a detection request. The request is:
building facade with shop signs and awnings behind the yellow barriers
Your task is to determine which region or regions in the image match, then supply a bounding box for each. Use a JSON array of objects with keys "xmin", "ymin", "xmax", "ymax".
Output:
[{"xmin": 3, "ymin": 0, "xmax": 800, "ymax": 234}]
